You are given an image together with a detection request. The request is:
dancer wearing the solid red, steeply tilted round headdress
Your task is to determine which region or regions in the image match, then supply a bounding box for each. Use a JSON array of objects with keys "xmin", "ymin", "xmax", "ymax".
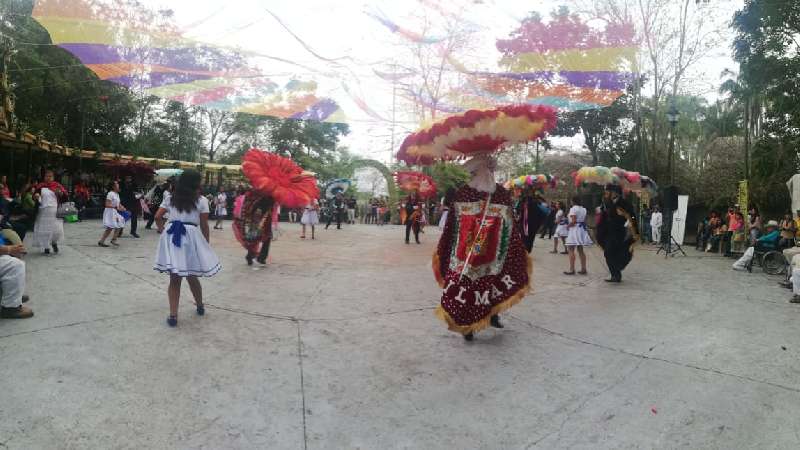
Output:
[{"xmin": 233, "ymin": 148, "xmax": 319, "ymax": 265}]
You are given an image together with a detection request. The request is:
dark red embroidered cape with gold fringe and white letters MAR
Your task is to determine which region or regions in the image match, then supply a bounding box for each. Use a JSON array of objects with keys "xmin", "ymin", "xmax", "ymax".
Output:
[{"xmin": 433, "ymin": 185, "xmax": 532, "ymax": 337}]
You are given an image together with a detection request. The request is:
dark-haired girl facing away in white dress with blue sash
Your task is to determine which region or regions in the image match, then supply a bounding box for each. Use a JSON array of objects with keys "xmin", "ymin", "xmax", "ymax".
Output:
[{"xmin": 153, "ymin": 170, "xmax": 222, "ymax": 327}]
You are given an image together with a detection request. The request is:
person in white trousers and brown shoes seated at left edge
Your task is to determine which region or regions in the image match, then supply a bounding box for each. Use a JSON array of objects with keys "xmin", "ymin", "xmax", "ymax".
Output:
[{"xmin": 0, "ymin": 236, "xmax": 33, "ymax": 319}]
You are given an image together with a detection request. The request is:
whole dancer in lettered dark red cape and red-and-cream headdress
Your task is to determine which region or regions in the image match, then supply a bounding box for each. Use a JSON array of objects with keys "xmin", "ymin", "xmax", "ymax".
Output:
[{"xmin": 398, "ymin": 106, "xmax": 555, "ymax": 340}]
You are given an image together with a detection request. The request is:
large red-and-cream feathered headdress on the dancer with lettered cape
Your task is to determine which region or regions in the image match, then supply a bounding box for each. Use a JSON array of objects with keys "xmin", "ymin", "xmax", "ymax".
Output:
[{"xmin": 397, "ymin": 105, "xmax": 556, "ymax": 165}]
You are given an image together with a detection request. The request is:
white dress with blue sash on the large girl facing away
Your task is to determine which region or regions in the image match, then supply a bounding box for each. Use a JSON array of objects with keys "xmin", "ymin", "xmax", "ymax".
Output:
[{"xmin": 153, "ymin": 196, "xmax": 222, "ymax": 277}]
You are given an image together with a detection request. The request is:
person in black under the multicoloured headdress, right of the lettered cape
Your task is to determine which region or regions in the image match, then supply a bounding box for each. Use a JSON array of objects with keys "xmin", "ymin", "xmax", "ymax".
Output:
[{"xmin": 597, "ymin": 185, "xmax": 639, "ymax": 283}]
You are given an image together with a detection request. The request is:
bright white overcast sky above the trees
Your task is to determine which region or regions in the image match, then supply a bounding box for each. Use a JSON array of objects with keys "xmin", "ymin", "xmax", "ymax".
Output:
[{"xmin": 31, "ymin": 0, "xmax": 743, "ymax": 169}]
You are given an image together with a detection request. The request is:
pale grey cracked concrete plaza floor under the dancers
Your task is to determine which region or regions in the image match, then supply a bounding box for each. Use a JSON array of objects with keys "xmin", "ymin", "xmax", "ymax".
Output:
[{"xmin": 0, "ymin": 221, "xmax": 800, "ymax": 449}]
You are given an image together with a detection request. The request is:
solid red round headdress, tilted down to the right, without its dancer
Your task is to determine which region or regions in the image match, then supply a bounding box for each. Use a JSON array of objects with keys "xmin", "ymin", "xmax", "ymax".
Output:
[{"xmin": 242, "ymin": 148, "xmax": 319, "ymax": 208}]
